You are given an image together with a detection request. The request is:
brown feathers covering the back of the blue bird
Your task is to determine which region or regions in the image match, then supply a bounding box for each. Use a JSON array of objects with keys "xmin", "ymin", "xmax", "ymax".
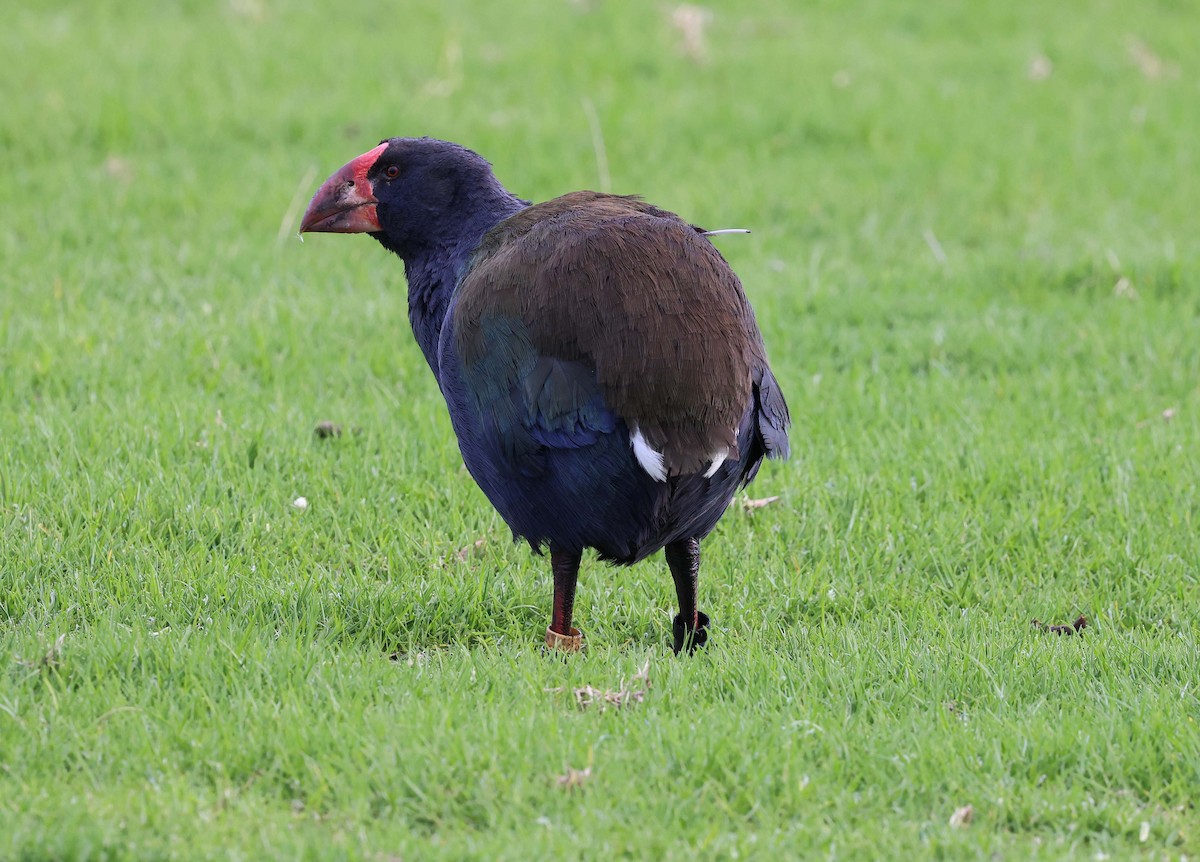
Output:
[{"xmin": 455, "ymin": 192, "xmax": 763, "ymax": 474}]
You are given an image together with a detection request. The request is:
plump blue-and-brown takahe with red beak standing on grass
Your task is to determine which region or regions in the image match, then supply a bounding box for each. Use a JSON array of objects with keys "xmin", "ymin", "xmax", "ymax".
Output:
[{"xmin": 300, "ymin": 138, "xmax": 790, "ymax": 652}]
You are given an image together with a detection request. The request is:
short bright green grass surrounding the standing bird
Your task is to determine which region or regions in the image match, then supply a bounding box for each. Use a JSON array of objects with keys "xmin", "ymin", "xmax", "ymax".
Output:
[{"xmin": 0, "ymin": 0, "xmax": 1200, "ymax": 860}]
